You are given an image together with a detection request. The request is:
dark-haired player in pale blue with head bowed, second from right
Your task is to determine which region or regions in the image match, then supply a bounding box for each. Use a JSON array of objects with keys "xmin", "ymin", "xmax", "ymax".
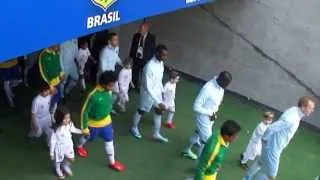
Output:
[{"xmin": 183, "ymin": 71, "xmax": 232, "ymax": 159}]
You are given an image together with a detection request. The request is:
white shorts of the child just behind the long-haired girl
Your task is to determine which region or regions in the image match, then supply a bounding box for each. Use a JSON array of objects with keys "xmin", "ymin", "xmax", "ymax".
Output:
[{"xmin": 28, "ymin": 117, "xmax": 52, "ymax": 139}]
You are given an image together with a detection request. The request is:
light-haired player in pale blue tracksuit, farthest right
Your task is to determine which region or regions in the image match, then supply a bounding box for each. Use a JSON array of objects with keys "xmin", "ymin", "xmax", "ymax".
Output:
[{"xmin": 244, "ymin": 96, "xmax": 315, "ymax": 180}]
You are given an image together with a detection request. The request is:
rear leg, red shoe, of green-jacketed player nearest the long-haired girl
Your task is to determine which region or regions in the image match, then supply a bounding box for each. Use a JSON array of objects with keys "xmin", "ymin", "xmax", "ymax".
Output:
[{"xmin": 76, "ymin": 127, "xmax": 101, "ymax": 158}]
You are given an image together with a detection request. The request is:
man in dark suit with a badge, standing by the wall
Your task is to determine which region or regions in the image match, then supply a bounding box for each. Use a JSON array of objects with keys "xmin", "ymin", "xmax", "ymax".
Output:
[{"xmin": 130, "ymin": 22, "xmax": 156, "ymax": 87}]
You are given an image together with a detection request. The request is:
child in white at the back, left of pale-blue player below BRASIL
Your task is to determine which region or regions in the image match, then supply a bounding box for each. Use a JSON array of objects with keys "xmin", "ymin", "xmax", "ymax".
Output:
[{"xmin": 76, "ymin": 41, "xmax": 96, "ymax": 90}]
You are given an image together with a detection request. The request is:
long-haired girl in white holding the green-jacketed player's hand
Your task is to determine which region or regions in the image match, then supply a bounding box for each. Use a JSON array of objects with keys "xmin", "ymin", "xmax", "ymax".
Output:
[{"xmin": 50, "ymin": 107, "xmax": 82, "ymax": 179}]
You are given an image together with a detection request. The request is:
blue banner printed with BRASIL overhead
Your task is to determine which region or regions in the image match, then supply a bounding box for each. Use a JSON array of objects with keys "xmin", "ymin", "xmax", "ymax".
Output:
[{"xmin": 0, "ymin": 0, "xmax": 210, "ymax": 62}]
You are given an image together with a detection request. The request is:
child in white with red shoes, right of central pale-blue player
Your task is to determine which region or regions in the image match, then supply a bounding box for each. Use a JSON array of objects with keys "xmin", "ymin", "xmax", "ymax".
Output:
[{"xmin": 163, "ymin": 71, "xmax": 180, "ymax": 129}]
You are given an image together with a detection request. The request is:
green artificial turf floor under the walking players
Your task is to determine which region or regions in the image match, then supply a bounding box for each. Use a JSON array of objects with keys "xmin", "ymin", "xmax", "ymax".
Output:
[{"xmin": 0, "ymin": 75, "xmax": 320, "ymax": 180}]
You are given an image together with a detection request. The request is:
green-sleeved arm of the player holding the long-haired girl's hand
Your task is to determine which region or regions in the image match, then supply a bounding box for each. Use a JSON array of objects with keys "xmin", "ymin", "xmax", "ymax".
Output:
[{"xmin": 81, "ymin": 91, "xmax": 94, "ymax": 134}]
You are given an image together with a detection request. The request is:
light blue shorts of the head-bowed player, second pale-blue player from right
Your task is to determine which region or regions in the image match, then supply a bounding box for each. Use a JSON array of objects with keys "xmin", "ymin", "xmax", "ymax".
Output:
[{"xmin": 194, "ymin": 113, "xmax": 214, "ymax": 142}]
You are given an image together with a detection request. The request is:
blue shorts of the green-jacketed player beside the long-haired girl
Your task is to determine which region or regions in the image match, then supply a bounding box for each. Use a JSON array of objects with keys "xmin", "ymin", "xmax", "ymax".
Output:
[{"xmin": 88, "ymin": 124, "xmax": 113, "ymax": 142}]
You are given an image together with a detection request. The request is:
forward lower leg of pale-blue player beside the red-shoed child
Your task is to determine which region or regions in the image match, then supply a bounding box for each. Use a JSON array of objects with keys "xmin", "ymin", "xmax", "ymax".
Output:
[{"xmin": 153, "ymin": 107, "xmax": 169, "ymax": 143}]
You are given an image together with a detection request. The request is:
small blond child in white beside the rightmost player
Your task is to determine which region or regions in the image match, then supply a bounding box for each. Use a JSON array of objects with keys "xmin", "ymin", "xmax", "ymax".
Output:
[{"xmin": 240, "ymin": 112, "xmax": 274, "ymax": 169}]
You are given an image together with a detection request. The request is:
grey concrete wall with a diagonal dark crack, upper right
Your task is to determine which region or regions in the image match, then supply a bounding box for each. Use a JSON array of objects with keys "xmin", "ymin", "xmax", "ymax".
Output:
[{"xmin": 115, "ymin": 0, "xmax": 320, "ymax": 123}]
